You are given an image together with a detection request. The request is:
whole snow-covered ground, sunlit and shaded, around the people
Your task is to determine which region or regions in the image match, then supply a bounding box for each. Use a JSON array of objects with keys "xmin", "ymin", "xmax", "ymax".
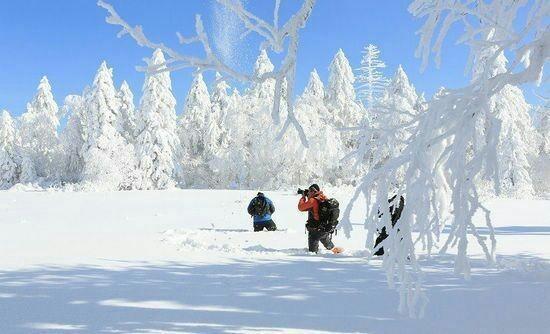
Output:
[{"xmin": 0, "ymin": 189, "xmax": 550, "ymax": 334}]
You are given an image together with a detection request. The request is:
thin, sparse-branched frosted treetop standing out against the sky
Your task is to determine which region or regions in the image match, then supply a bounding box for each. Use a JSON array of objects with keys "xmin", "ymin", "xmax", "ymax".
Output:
[{"xmin": 356, "ymin": 44, "xmax": 388, "ymax": 108}]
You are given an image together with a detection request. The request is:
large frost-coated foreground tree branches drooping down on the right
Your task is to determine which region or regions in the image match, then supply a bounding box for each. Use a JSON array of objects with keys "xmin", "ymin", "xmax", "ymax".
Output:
[{"xmin": 342, "ymin": 0, "xmax": 550, "ymax": 316}]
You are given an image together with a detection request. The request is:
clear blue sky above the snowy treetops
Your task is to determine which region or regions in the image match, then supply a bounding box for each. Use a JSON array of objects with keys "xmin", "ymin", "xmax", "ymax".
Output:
[{"xmin": 0, "ymin": 0, "xmax": 544, "ymax": 115}]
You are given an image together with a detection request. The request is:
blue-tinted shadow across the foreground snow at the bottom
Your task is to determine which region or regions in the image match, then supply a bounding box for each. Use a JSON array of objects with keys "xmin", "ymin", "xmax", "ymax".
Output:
[{"xmin": 0, "ymin": 256, "xmax": 550, "ymax": 334}]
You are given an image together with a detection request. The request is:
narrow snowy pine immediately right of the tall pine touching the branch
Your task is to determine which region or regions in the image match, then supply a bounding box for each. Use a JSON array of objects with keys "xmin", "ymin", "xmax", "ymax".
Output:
[{"xmin": 179, "ymin": 73, "xmax": 215, "ymax": 187}]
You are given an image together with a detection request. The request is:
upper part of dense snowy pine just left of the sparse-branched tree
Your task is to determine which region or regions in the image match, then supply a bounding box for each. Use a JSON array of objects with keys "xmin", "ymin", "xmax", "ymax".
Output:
[{"xmin": 326, "ymin": 49, "xmax": 365, "ymax": 127}]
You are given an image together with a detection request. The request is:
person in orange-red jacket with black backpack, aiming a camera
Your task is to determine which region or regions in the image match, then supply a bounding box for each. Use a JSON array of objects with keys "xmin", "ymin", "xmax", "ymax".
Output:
[{"xmin": 298, "ymin": 183, "xmax": 342, "ymax": 253}]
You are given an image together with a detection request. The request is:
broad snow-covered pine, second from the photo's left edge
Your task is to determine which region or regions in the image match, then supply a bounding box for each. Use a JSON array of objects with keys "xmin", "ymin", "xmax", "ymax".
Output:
[{"xmin": 20, "ymin": 76, "xmax": 60, "ymax": 183}]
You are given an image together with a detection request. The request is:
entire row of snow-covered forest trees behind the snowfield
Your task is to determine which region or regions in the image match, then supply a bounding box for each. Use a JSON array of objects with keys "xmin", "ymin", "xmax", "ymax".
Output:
[{"xmin": 0, "ymin": 44, "xmax": 550, "ymax": 196}]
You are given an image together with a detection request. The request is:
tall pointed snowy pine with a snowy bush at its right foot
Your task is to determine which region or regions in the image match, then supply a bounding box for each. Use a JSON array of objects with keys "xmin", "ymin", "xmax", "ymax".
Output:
[{"xmin": 82, "ymin": 62, "xmax": 135, "ymax": 190}]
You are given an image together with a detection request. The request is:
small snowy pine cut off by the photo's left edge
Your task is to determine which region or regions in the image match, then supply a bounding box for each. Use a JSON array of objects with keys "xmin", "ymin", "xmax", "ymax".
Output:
[{"xmin": 0, "ymin": 110, "xmax": 21, "ymax": 189}]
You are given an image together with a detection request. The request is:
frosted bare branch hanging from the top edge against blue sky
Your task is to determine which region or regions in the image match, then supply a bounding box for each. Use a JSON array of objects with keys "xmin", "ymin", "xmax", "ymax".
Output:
[{"xmin": 97, "ymin": 0, "xmax": 316, "ymax": 147}]
